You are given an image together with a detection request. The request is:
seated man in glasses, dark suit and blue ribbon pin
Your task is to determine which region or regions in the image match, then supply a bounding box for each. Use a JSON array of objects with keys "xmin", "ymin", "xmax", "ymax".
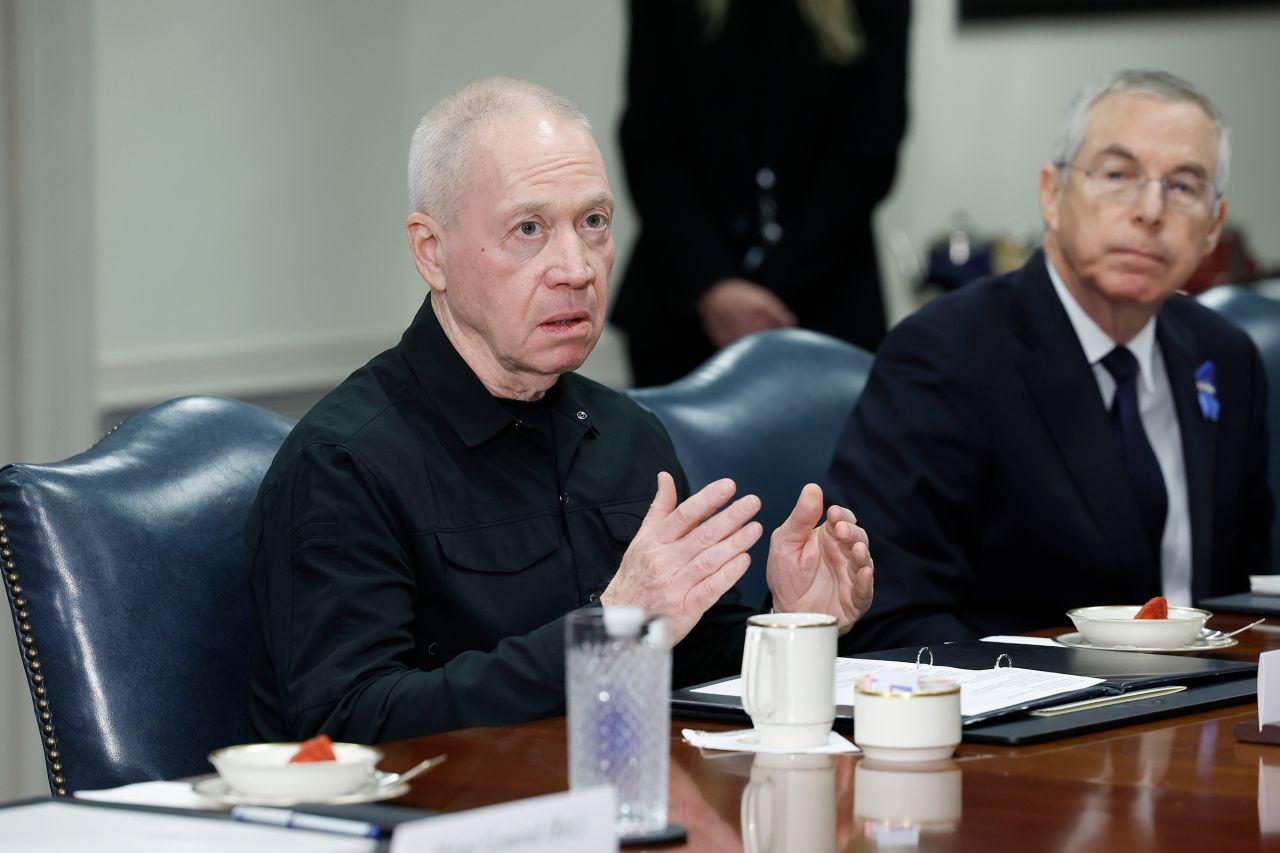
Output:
[{"xmin": 828, "ymin": 72, "xmax": 1272, "ymax": 648}]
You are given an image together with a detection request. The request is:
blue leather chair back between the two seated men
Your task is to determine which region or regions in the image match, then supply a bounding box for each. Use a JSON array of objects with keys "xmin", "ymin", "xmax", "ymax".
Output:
[{"xmin": 628, "ymin": 329, "xmax": 872, "ymax": 606}]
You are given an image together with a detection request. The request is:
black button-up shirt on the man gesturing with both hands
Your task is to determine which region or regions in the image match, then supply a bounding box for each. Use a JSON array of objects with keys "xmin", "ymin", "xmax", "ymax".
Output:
[{"xmin": 246, "ymin": 298, "xmax": 754, "ymax": 743}]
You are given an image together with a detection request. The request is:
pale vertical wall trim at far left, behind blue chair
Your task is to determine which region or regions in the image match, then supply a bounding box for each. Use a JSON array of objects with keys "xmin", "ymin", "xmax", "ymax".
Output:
[{"xmin": 0, "ymin": 0, "xmax": 96, "ymax": 798}]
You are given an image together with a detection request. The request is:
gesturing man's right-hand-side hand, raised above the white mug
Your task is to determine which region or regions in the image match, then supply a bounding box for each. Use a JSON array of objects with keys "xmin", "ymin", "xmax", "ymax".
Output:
[{"xmin": 767, "ymin": 483, "xmax": 873, "ymax": 634}]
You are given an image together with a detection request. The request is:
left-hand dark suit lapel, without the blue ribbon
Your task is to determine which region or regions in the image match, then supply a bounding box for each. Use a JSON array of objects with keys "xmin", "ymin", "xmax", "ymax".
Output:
[{"xmin": 1012, "ymin": 252, "xmax": 1160, "ymax": 601}]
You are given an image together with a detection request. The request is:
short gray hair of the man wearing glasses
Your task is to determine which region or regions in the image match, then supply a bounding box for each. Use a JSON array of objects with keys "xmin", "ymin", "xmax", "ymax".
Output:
[{"xmin": 1053, "ymin": 70, "xmax": 1231, "ymax": 193}]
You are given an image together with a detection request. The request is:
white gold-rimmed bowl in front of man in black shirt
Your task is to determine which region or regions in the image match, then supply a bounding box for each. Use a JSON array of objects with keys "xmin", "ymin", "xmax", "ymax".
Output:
[{"xmin": 209, "ymin": 743, "xmax": 383, "ymax": 802}]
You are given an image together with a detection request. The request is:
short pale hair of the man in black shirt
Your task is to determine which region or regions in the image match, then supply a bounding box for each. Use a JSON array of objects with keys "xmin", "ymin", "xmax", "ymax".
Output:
[{"xmin": 408, "ymin": 77, "xmax": 591, "ymax": 222}]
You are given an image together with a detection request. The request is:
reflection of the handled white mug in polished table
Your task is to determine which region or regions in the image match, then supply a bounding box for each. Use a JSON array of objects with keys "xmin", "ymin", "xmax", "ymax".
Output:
[{"xmin": 741, "ymin": 752, "xmax": 836, "ymax": 853}]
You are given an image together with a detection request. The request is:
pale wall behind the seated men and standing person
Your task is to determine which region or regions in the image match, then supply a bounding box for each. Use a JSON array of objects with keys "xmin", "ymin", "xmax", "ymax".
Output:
[{"xmin": 0, "ymin": 0, "xmax": 1280, "ymax": 797}]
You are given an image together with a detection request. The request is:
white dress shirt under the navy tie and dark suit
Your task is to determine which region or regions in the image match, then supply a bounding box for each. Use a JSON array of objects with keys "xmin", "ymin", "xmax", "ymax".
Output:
[{"xmin": 1044, "ymin": 257, "xmax": 1192, "ymax": 607}]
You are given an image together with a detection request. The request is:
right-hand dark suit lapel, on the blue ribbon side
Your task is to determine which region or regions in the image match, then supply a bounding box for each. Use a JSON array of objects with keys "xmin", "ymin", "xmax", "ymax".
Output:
[{"xmin": 1156, "ymin": 306, "xmax": 1215, "ymax": 601}]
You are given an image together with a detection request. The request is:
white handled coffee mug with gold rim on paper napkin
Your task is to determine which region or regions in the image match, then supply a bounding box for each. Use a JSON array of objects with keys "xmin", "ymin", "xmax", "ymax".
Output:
[{"xmin": 742, "ymin": 613, "xmax": 837, "ymax": 749}]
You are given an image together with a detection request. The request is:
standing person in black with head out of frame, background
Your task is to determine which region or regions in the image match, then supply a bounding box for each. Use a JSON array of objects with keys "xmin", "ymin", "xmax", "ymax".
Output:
[{"xmin": 613, "ymin": 0, "xmax": 910, "ymax": 386}]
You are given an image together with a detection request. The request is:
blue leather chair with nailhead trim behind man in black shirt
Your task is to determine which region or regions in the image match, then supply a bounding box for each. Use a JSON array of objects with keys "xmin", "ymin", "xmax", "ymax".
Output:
[{"xmin": 0, "ymin": 397, "xmax": 292, "ymax": 795}]
